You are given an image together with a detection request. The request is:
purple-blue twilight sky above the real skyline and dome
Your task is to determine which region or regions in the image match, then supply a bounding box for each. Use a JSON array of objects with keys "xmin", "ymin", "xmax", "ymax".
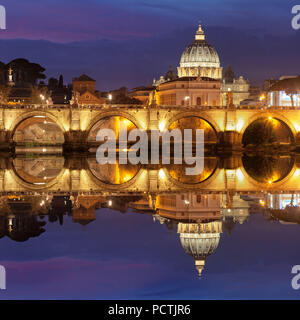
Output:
[{"xmin": 0, "ymin": 0, "xmax": 300, "ymax": 90}]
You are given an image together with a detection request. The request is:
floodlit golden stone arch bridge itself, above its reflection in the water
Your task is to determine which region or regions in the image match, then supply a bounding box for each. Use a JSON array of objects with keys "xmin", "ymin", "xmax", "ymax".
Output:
[{"xmin": 0, "ymin": 104, "xmax": 300, "ymax": 149}]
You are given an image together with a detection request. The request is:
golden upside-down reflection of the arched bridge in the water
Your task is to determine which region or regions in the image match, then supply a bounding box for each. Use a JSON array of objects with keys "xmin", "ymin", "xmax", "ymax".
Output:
[{"xmin": 0, "ymin": 150, "xmax": 300, "ymax": 195}]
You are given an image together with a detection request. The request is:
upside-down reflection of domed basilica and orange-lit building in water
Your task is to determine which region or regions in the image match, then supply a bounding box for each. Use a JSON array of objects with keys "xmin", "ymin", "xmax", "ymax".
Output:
[{"xmin": 155, "ymin": 193, "xmax": 222, "ymax": 277}]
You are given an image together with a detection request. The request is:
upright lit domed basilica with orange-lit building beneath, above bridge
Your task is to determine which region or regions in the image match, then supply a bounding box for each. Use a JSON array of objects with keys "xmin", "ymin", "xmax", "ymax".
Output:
[{"xmin": 153, "ymin": 25, "xmax": 222, "ymax": 106}]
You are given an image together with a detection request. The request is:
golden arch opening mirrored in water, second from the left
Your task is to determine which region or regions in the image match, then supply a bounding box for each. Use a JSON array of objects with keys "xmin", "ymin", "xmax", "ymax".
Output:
[{"xmin": 88, "ymin": 159, "xmax": 139, "ymax": 185}]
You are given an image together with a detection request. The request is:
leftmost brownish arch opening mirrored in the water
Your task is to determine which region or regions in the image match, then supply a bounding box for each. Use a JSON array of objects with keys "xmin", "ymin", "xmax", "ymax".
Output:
[{"xmin": 13, "ymin": 157, "xmax": 65, "ymax": 185}]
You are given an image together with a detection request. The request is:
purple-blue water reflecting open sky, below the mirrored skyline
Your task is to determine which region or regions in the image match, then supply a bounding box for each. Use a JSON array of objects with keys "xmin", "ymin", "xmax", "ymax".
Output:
[{"xmin": 0, "ymin": 209, "xmax": 300, "ymax": 299}]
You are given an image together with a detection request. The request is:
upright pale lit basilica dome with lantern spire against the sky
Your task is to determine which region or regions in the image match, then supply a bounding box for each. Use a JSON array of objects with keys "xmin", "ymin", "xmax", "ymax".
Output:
[{"xmin": 177, "ymin": 25, "xmax": 222, "ymax": 79}]
